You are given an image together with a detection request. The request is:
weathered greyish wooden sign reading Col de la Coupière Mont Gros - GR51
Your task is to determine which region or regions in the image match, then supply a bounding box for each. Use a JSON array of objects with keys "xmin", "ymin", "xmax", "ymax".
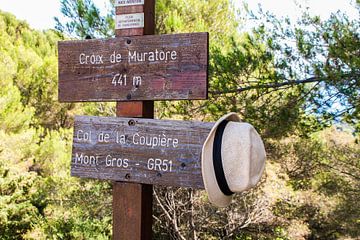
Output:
[{"xmin": 71, "ymin": 116, "xmax": 213, "ymax": 188}]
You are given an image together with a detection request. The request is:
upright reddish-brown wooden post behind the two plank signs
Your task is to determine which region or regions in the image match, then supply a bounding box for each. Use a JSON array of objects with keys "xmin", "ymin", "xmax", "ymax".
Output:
[{"xmin": 113, "ymin": 0, "xmax": 155, "ymax": 240}]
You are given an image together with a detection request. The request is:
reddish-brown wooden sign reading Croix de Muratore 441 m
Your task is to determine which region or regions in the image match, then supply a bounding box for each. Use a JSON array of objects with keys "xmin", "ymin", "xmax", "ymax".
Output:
[{"xmin": 58, "ymin": 33, "xmax": 209, "ymax": 102}]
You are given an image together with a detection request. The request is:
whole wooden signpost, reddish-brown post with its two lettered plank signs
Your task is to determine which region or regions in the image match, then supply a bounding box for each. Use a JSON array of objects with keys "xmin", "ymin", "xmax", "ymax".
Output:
[{"xmin": 58, "ymin": 0, "xmax": 213, "ymax": 240}]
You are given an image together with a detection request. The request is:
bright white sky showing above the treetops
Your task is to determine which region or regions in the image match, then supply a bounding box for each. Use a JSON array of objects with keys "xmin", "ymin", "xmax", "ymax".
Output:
[{"xmin": 0, "ymin": 0, "xmax": 359, "ymax": 30}]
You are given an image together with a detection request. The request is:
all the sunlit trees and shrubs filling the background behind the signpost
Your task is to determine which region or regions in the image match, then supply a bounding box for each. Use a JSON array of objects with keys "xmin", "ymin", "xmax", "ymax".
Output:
[{"xmin": 0, "ymin": 0, "xmax": 360, "ymax": 239}]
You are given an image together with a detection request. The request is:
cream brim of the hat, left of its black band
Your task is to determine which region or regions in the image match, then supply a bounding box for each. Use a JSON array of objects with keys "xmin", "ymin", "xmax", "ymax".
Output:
[{"xmin": 201, "ymin": 112, "xmax": 241, "ymax": 207}]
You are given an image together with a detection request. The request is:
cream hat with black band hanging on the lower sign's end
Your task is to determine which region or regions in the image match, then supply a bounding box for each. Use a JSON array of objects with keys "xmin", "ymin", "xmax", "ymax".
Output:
[{"xmin": 201, "ymin": 113, "xmax": 266, "ymax": 207}]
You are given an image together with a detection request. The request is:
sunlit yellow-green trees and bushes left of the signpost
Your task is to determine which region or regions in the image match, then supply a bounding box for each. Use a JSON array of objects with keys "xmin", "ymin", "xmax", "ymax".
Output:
[{"xmin": 0, "ymin": 8, "xmax": 111, "ymax": 239}]
